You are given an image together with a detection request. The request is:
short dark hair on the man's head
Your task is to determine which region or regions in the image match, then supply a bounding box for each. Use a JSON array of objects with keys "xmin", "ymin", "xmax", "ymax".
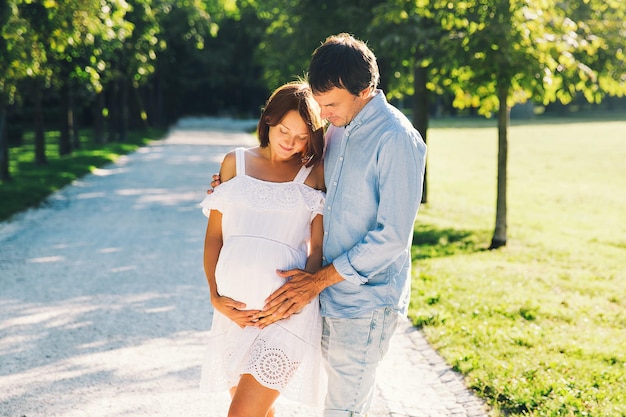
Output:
[{"xmin": 308, "ymin": 33, "xmax": 379, "ymax": 96}]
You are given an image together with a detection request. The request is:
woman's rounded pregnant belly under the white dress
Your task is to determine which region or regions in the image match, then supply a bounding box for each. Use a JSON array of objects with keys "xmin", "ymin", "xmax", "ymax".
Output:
[{"xmin": 215, "ymin": 237, "xmax": 306, "ymax": 310}]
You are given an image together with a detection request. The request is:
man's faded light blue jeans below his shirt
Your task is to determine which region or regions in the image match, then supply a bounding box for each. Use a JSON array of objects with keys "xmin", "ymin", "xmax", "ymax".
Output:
[{"xmin": 322, "ymin": 308, "xmax": 399, "ymax": 417}]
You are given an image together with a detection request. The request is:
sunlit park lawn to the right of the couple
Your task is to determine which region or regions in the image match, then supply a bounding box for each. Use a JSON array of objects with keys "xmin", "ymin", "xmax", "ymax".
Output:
[{"xmin": 409, "ymin": 116, "xmax": 626, "ymax": 417}]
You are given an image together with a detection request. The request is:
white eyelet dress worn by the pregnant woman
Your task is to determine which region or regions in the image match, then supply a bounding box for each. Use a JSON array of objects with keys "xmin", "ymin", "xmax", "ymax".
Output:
[{"xmin": 200, "ymin": 148, "xmax": 326, "ymax": 406}]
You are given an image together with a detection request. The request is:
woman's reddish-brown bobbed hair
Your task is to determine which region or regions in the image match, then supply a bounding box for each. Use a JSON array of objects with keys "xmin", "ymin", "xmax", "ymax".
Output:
[{"xmin": 257, "ymin": 82, "xmax": 324, "ymax": 166}]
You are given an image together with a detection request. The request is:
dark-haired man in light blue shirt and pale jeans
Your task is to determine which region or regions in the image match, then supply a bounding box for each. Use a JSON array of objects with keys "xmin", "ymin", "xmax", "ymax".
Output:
[{"xmin": 258, "ymin": 33, "xmax": 426, "ymax": 417}]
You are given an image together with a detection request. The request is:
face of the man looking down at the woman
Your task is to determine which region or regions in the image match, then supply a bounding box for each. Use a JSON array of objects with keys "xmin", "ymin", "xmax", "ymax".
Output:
[{"xmin": 313, "ymin": 87, "xmax": 371, "ymax": 127}]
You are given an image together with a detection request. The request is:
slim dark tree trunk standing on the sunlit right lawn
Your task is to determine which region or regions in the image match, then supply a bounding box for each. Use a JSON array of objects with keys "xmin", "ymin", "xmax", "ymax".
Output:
[{"xmin": 489, "ymin": 82, "xmax": 510, "ymax": 249}]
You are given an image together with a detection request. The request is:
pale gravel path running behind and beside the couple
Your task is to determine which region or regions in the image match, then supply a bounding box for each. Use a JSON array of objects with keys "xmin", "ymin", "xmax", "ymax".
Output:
[{"xmin": 0, "ymin": 119, "xmax": 486, "ymax": 417}]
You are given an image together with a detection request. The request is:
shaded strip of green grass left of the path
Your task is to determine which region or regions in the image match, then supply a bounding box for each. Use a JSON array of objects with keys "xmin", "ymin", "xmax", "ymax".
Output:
[{"xmin": 0, "ymin": 130, "xmax": 164, "ymax": 221}]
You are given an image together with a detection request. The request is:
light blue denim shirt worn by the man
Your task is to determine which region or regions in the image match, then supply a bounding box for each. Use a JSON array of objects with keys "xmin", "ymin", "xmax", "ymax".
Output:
[{"xmin": 320, "ymin": 90, "xmax": 426, "ymax": 318}]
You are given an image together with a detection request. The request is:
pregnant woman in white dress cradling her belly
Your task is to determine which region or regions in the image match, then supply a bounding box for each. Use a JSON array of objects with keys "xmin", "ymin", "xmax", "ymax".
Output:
[{"xmin": 201, "ymin": 82, "xmax": 325, "ymax": 417}]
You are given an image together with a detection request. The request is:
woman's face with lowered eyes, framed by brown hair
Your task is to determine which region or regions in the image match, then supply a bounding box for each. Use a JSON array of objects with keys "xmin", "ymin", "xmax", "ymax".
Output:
[{"xmin": 269, "ymin": 110, "xmax": 309, "ymax": 159}]
